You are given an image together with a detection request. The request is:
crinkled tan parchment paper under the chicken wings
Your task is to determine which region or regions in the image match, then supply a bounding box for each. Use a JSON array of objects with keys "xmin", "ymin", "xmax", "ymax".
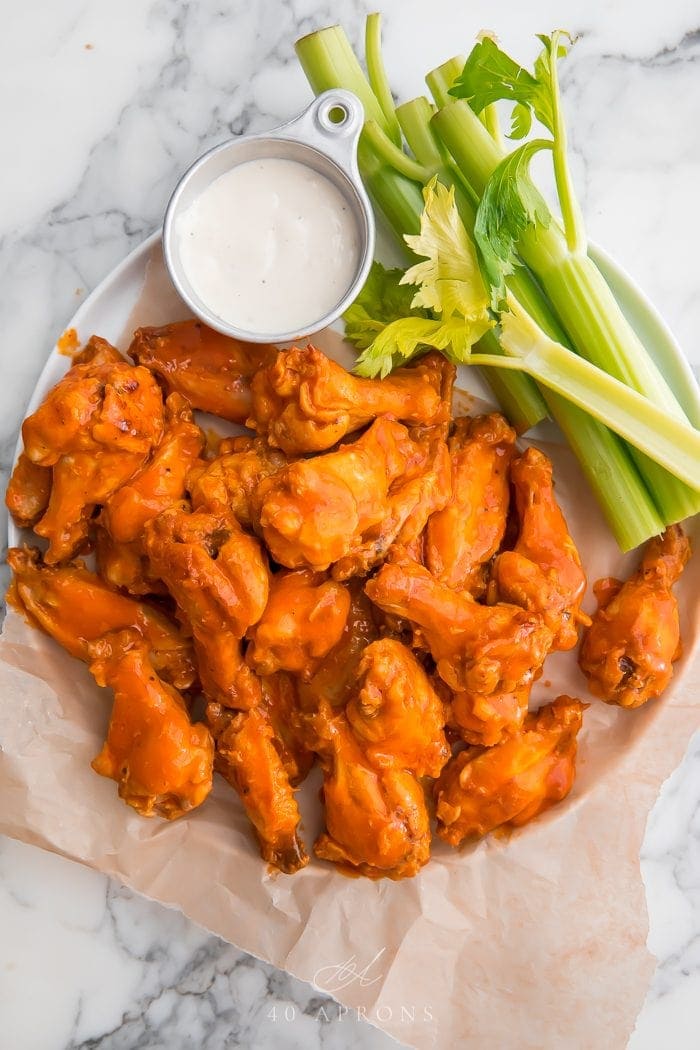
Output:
[{"xmin": 0, "ymin": 243, "xmax": 700, "ymax": 1050}]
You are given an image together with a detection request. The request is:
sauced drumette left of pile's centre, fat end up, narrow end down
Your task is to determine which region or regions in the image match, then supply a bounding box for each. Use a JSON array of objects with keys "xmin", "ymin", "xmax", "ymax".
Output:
[{"xmin": 144, "ymin": 505, "xmax": 270, "ymax": 708}]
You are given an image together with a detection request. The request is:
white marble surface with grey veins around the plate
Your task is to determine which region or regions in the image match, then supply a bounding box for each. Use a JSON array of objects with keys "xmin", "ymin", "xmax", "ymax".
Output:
[{"xmin": 0, "ymin": 0, "xmax": 700, "ymax": 1050}]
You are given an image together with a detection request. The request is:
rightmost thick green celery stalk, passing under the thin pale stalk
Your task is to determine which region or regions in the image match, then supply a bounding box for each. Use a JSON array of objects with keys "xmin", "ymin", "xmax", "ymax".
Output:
[{"xmin": 431, "ymin": 99, "xmax": 700, "ymax": 524}]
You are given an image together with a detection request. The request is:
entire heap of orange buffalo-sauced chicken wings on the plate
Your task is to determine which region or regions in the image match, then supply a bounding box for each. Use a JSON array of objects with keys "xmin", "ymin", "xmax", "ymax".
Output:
[{"xmin": 6, "ymin": 321, "xmax": 690, "ymax": 879}]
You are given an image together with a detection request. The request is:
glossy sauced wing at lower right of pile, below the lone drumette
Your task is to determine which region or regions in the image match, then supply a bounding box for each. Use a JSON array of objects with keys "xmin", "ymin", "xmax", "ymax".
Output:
[{"xmin": 434, "ymin": 696, "xmax": 586, "ymax": 846}]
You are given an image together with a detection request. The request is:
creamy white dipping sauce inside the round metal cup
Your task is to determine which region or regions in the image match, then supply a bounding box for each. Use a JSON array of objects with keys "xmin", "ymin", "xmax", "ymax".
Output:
[{"xmin": 176, "ymin": 158, "xmax": 359, "ymax": 334}]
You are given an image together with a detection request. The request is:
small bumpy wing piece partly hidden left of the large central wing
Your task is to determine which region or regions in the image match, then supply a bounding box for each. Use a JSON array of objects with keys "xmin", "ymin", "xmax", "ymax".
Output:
[{"xmin": 187, "ymin": 437, "xmax": 287, "ymax": 527}]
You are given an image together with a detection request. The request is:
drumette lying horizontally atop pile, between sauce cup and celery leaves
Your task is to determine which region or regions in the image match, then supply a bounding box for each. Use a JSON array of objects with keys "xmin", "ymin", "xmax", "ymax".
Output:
[{"xmin": 248, "ymin": 345, "xmax": 454, "ymax": 456}]
